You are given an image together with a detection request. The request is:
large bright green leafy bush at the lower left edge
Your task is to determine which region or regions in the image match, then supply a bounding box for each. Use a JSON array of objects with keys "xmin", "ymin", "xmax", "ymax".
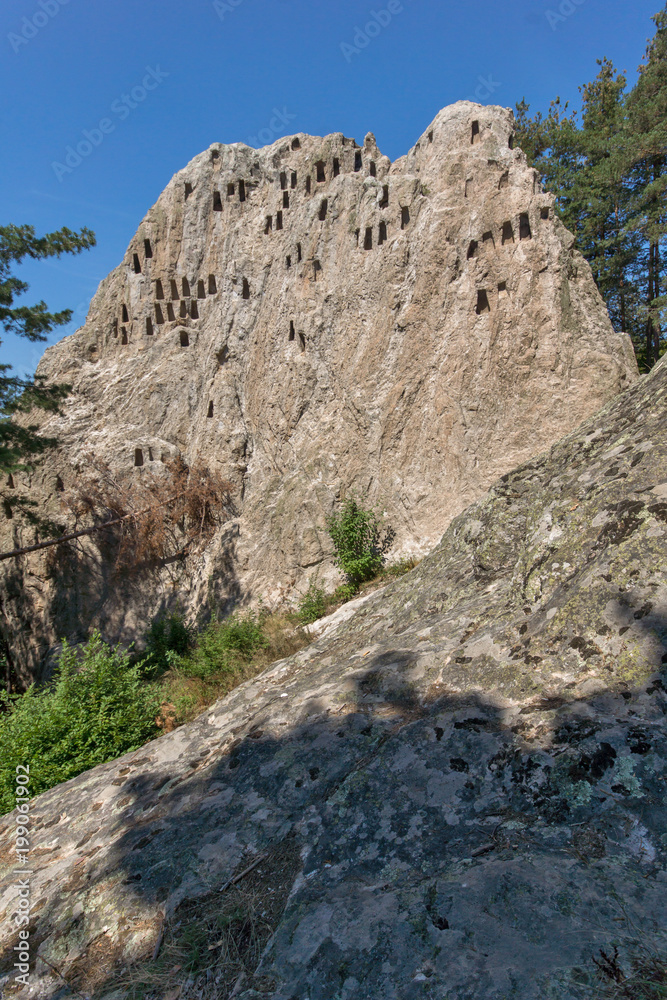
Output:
[{"xmin": 0, "ymin": 631, "xmax": 160, "ymax": 813}]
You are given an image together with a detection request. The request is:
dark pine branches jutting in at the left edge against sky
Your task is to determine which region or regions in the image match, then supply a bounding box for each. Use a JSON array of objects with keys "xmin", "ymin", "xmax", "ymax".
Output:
[{"xmin": 0, "ymin": 225, "xmax": 95, "ymax": 472}]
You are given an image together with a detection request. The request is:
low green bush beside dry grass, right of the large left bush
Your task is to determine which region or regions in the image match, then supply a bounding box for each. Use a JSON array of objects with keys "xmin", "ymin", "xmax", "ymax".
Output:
[{"xmin": 178, "ymin": 611, "xmax": 270, "ymax": 679}]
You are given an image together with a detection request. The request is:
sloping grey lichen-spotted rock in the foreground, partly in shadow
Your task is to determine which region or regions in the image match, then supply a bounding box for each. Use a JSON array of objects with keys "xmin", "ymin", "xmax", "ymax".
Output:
[{"xmin": 0, "ymin": 361, "xmax": 667, "ymax": 1000}]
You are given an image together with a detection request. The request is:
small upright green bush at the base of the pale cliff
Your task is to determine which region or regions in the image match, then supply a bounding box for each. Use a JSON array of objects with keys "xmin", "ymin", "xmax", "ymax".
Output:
[{"xmin": 327, "ymin": 497, "xmax": 395, "ymax": 590}]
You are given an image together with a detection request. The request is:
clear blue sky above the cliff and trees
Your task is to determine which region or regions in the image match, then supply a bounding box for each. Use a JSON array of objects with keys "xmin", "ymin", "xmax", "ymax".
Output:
[{"xmin": 0, "ymin": 0, "xmax": 661, "ymax": 374}]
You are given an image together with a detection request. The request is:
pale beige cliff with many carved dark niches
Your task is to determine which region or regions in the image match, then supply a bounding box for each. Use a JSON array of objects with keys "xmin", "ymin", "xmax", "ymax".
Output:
[{"xmin": 2, "ymin": 102, "xmax": 636, "ymax": 672}]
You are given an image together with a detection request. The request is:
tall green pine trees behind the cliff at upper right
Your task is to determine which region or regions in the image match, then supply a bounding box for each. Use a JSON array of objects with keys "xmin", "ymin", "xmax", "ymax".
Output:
[{"xmin": 517, "ymin": 6, "xmax": 667, "ymax": 370}]
